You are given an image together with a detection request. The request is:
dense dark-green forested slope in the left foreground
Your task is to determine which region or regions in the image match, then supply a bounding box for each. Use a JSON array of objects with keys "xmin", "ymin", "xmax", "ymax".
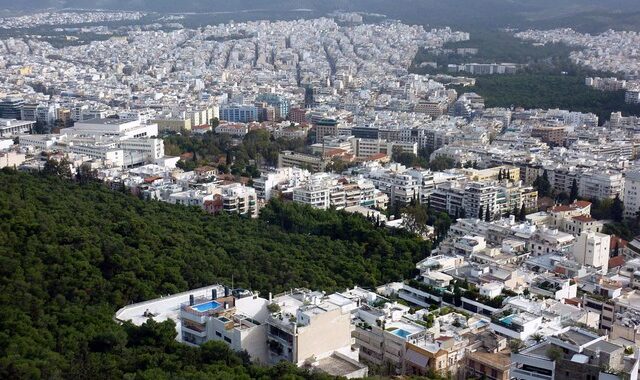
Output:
[{"xmin": 0, "ymin": 170, "xmax": 430, "ymax": 379}]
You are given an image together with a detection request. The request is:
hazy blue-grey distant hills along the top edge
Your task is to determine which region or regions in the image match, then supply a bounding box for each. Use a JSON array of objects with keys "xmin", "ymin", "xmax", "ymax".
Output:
[{"xmin": 0, "ymin": 0, "xmax": 640, "ymax": 31}]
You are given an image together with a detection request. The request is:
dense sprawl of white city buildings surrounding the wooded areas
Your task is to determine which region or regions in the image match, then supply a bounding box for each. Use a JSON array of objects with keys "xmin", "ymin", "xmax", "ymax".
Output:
[{"xmin": 6, "ymin": 12, "xmax": 640, "ymax": 380}]
